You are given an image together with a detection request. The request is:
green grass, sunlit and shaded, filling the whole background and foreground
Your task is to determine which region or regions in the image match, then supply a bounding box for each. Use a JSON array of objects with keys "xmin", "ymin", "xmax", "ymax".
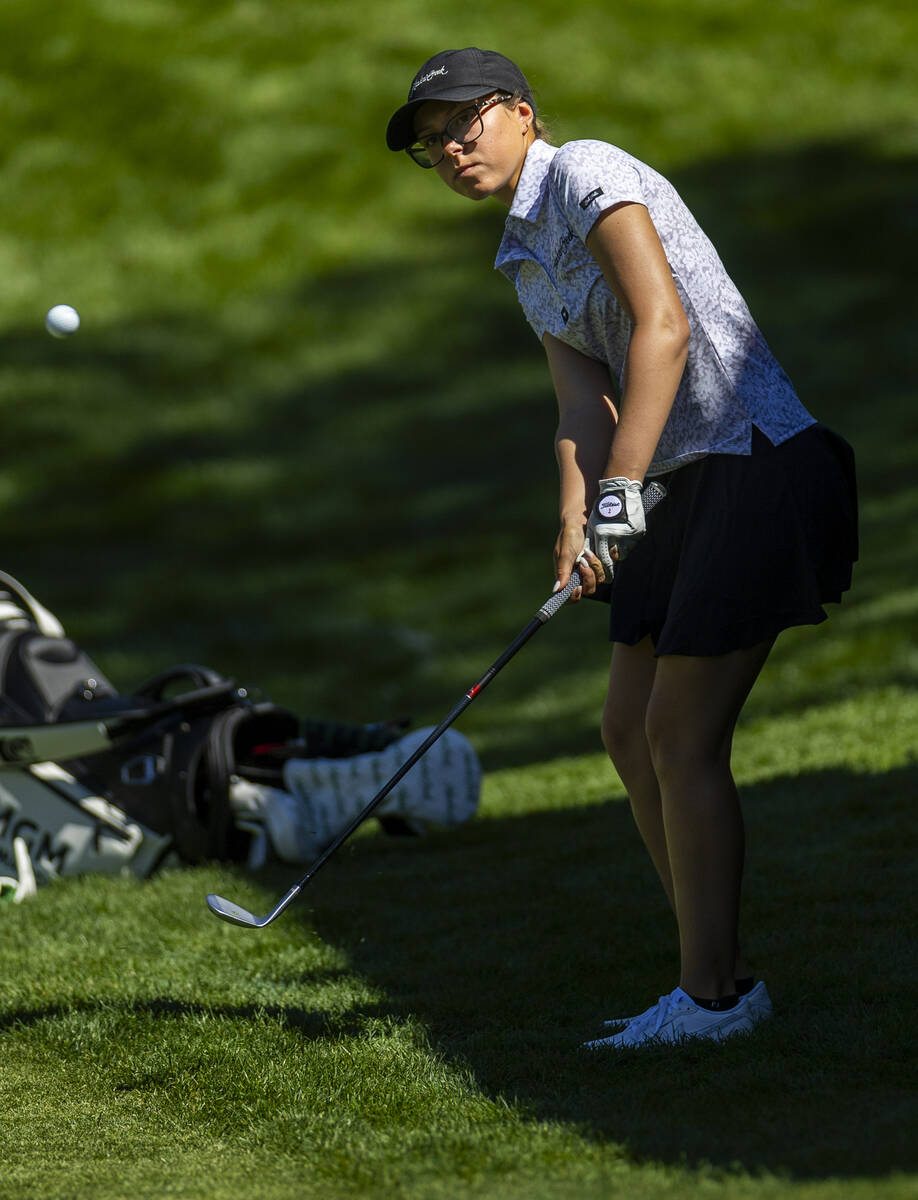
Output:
[{"xmin": 0, "ymin": 0, "xmax": 918, "ymax": 1200}]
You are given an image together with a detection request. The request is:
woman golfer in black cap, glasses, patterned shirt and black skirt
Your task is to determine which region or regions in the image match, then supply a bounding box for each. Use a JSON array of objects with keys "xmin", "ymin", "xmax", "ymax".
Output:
[{"xmin": 386, "ymin": 48, "xmax": 857, "ymax": 1048}]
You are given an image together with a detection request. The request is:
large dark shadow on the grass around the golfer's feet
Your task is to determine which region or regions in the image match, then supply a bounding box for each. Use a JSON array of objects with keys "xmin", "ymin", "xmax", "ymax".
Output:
[{"xmin": 290, "ymin": 766, "xmax": 918, "ymax": 1178}]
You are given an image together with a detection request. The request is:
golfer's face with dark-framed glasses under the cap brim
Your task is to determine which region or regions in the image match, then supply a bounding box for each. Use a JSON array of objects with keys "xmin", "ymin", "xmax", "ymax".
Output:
[{"xmin": 414, "ymin": 100, "xmax": 534, "ymax": 206}]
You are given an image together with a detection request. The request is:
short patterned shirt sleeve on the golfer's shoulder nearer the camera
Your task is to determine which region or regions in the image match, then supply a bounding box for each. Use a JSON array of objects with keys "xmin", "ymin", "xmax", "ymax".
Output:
[{"xmin": 548, "ymin": 142, "xmax": 647, "ymax": 241}]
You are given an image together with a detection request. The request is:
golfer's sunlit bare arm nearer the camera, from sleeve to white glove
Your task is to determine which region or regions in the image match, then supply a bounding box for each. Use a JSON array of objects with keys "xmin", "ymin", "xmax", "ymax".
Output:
[{"xmin": 587, "ymin": 204, "xmax": 689, "ymax": 480}]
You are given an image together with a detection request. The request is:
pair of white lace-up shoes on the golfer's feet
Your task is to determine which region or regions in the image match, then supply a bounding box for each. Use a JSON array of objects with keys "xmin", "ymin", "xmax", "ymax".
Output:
[{"xmin": 584, "ymin": 983, "xmax": 772, "ymax": 1050}]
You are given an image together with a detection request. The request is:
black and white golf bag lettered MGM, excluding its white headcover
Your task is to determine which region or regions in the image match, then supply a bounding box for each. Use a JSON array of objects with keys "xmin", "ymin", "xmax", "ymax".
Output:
[{"xmin": 0, "ymin": 572, "xmax": 299, "ymax": 882}]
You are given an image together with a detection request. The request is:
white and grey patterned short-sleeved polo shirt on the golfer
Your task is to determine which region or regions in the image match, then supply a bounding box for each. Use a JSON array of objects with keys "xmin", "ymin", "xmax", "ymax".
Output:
[{"xmin": 494, "ymin": 140, "xmax": 815, "ymax": 475}]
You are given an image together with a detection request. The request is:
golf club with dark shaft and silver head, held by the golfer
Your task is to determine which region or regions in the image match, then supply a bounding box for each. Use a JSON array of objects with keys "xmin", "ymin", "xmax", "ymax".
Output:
[{"xmin": 208, "ymin": 482, "xmax": 666, "ymax": 929}]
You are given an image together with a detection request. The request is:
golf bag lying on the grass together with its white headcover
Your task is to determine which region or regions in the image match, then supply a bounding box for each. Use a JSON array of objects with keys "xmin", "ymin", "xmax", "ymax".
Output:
[{"xmin": 0, "ymin": 571, "xmax": 480, "ymax": 882}]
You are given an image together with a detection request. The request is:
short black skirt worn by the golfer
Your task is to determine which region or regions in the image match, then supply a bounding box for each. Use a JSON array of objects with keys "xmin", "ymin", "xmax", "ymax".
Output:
[{"xmin": 607, "ymin": 425, "xmax": 858, "ymax": 655}]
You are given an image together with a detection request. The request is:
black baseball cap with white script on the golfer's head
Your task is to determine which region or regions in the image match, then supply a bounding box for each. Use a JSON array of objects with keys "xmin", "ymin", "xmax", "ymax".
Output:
[{"xmin": 385, "ymin": 46, "xmax": 535, "ymax": 150}]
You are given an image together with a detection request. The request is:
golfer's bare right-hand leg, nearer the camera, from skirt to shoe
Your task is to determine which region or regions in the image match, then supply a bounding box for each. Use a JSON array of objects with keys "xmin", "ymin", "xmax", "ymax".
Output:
[{"xmin": 646, "ymin": 642, "xmax": 772, "ymax": 998}]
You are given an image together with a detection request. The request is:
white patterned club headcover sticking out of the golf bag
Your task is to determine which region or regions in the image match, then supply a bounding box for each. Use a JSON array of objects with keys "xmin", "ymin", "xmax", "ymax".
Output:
[{"xmin": 229, "ymin": 728, "xmax": 481, "ymax": 868}]
